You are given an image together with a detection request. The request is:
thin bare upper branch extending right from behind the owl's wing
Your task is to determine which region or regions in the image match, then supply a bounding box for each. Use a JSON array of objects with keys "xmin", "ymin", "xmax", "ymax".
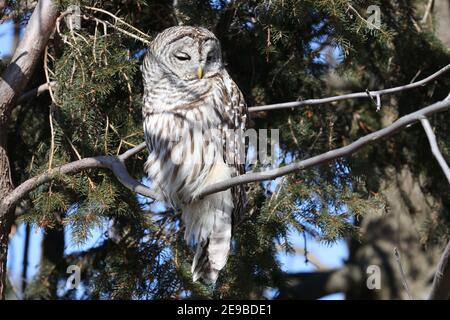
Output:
[{"xmin": 248, "ymin": 64, "xmax": 450, "ymax": 112}]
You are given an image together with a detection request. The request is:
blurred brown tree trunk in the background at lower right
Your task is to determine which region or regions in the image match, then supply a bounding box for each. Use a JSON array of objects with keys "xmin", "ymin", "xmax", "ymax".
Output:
[{"xmin": 346, "ymin": 166, "xmax": 442, "ymax": 299}]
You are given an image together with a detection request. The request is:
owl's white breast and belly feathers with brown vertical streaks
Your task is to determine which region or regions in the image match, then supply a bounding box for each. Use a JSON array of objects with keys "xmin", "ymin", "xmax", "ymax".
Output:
[{"xmin": 143, "ymin": 76, "xmax": 230, "ymax": 208}]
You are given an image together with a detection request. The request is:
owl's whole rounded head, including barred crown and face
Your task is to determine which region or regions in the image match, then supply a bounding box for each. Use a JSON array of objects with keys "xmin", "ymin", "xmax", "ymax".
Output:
[{"xmin": 149, "ymin": 26, "xmax": 223, "ymax": 81}]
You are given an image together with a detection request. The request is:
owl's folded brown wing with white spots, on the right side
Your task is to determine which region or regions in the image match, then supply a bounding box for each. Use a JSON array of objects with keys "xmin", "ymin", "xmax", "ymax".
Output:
[{"xmin": 216, "ymin": 71, "xmax": 248, "ymax": 227}]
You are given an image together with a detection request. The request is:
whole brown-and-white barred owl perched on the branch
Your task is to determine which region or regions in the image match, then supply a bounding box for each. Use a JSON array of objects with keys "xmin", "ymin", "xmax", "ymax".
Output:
[{"xmin": 141, "ymin": 26, "xmax": 247, "ymax": 284}]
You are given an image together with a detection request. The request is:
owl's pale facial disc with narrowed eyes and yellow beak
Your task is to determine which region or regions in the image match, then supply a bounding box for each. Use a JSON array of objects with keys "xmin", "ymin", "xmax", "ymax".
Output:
[{"xmin": 163, "ymin": 36, "xmax": 222, "ymax": 81}]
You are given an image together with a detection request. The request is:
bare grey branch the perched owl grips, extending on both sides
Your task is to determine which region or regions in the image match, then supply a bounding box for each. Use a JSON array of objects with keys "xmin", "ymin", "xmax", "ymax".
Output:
[{"xmin": 0, "ymin": 100, "xmax": 450, "ymax": 218}]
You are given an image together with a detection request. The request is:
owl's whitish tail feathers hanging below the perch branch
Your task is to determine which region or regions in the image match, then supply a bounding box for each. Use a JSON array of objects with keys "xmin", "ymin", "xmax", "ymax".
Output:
[{"xmin": 182, "ymin": 176, "xmax": 233, "ymax": 284}]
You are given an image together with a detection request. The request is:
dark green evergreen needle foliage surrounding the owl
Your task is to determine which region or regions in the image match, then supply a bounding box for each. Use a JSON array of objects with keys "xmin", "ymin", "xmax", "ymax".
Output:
[{"xmin": 4, "ymin": 0, "xmax": 450, "ymax": 299}]
